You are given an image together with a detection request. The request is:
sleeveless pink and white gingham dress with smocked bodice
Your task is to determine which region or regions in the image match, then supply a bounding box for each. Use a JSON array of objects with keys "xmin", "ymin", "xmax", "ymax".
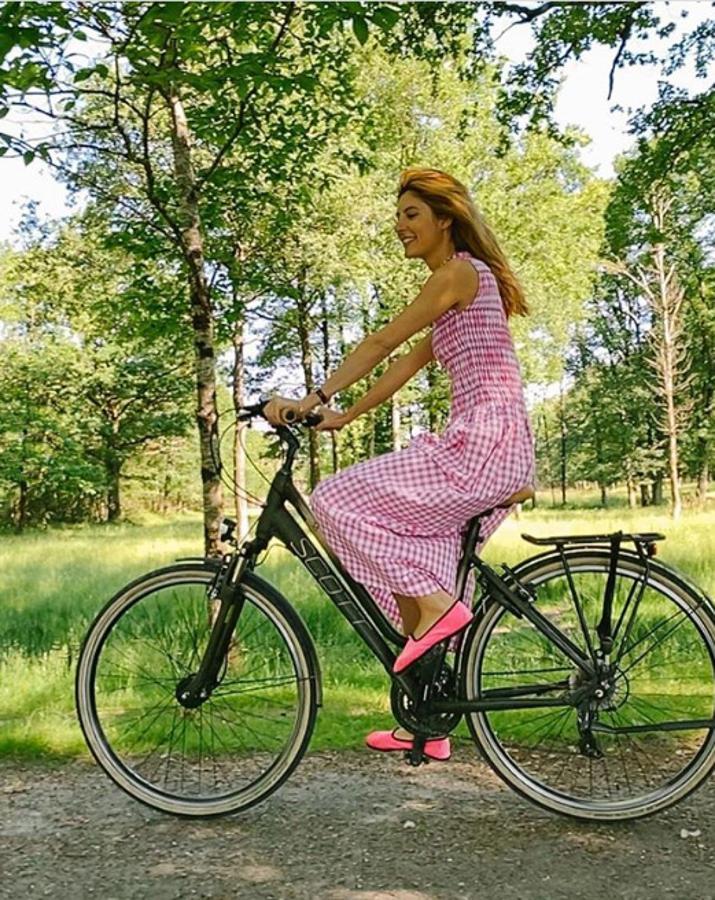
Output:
[{"xmin": 309, "ymin": 251, "xmax": 535, "ymax": 628}]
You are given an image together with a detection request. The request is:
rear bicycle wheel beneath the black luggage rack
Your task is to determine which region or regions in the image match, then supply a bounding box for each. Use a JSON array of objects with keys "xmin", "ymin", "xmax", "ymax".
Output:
[{"xmin": 463, "ymin": 549, "xmax": 715, "ymax": 821}]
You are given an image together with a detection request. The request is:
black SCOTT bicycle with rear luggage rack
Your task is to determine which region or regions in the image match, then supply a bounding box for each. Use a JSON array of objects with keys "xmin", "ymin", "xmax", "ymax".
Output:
[{"xmin": 76, "ymin": 401, "xmax": 715, "ymax": 821}]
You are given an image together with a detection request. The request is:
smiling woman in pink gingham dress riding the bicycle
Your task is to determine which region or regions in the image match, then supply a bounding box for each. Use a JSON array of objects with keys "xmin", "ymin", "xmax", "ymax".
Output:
[{"xmin": 265, "ymin": 168, "xmax": 534, "ymax": 759}]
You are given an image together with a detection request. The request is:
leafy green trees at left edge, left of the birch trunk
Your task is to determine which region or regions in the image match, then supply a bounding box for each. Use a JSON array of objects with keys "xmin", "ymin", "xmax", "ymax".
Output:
[{"xmin": 0, "ymin": 211, "xmax": 196, "ymax": 528}]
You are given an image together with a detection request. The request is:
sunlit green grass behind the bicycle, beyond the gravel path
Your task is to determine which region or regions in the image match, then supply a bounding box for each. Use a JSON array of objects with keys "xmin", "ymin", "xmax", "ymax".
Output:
[{"xmin": 0, "ymin": 495, "xmax": 715, "ymax": 759}]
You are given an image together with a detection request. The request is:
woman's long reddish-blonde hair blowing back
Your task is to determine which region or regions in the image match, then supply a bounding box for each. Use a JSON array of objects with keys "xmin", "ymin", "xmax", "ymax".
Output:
[{"xmin": 397, "ymin": 166, "xmax": 529, "ymax": 319}]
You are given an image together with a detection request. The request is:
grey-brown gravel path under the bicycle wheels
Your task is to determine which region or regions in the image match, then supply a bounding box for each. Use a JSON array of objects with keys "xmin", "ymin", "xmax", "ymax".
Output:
[{"xmin": 0, "ymin": 747, "xmax": 715, "ymax": 900}]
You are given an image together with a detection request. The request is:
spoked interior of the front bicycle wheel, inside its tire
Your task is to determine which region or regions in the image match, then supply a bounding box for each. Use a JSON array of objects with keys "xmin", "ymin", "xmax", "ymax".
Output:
[{"xmin": 79, "ymin": 576, "xmax": 315, "ymax": 810}]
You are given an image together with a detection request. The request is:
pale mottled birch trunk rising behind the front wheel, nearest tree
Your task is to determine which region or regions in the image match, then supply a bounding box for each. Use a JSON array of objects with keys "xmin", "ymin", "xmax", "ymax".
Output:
[{"xmin": 166, "ymin": 86, "xmax": 223, "ymax": 556}]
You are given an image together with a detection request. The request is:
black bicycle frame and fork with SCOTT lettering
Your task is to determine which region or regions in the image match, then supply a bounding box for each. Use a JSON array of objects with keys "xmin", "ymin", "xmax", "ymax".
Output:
[{"xmin": 192, "ymin": 418, "xmax": 715, "ymax": 733}]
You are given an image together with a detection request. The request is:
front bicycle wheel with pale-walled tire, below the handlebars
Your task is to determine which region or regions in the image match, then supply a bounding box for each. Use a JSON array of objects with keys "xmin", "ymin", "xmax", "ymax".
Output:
[{"xmin": 76, "ymin": 564, "xmax": 319, "ymax": 816}]
